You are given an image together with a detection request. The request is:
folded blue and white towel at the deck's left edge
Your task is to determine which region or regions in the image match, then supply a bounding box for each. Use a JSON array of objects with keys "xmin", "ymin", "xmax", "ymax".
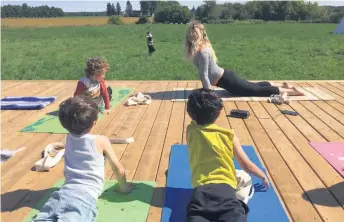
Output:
[{"xmin": 0, "ymin": 96, "xmax": 56, "ymax": 110}]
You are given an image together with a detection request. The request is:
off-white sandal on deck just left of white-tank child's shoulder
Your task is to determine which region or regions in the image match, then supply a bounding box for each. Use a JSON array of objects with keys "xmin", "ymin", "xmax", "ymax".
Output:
[{"xmin": 35, "ymin": 143, "xmax": 65, "ymax": 172}]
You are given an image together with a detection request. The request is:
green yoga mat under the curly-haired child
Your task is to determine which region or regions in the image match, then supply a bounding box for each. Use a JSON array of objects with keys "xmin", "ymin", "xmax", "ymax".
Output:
[{"xmin": 19, "ymin": 88, "xmax": 132, "ymax": 133}]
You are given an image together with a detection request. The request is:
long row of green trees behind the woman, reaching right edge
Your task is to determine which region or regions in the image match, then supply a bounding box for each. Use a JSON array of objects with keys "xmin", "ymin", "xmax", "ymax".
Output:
[{"xmin": 195, "ymin": 1, "xmax": 344, "ymax": 23}]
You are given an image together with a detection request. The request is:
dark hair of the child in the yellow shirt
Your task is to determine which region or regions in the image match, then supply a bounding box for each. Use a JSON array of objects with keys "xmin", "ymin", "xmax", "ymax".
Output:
[{"xmin": 187, "ymin": 88, "xmax": 223, "ymax": 125}]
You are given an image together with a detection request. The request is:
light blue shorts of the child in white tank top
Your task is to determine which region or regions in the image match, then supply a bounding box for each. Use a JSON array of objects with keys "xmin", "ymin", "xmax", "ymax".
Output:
[{"xmin": 30, "ymin": 189, "xmax": 97, "ymax": 222}]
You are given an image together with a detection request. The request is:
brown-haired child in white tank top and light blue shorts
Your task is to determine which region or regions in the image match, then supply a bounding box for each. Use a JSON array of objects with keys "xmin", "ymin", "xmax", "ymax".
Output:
[{"xmin": 31, "ymin": 96, "xmax": 134, "ymax": 222}]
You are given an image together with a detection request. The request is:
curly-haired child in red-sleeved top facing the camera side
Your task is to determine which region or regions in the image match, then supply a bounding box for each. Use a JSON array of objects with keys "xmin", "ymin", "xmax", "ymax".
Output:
[{"xmin": 74, "ymin": 58, "xmax": 112, "ymax": 114}]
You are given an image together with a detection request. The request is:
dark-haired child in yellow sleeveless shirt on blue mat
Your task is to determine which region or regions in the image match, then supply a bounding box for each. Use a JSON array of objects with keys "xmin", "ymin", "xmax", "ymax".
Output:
[{"xmin": 186, "ymin": 89, "xmax": 269, "ymax": 222}]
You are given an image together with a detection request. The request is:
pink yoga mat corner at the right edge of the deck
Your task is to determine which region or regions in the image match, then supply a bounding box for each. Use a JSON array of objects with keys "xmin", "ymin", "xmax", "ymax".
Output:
[{"xmin": 309, "ymin": 142, "xmax": 344, "ymax": 177}]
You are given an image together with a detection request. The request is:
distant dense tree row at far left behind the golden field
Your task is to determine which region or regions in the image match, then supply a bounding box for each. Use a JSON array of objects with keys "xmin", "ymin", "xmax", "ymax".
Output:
[{"xmin": 1, "ymin": 3, "xmax": 64, "ymax": 18}]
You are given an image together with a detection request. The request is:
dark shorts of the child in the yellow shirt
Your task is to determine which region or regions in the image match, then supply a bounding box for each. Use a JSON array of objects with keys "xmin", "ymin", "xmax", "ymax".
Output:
[{"xmin": 187, "ymin": 184, "xmax": 249, "ymax": 222}]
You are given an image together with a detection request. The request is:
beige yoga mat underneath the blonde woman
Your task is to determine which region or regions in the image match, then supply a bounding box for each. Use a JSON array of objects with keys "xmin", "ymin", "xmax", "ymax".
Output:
[{"xmin": 172, "ymin": 87, "xmax": 335, "ymax": 102}]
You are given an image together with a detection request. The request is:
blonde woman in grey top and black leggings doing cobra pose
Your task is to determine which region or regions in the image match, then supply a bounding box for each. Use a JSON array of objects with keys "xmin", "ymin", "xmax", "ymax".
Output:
[{"xmin": 184, "ymin": 21, "xmax": 304, "ymax": 97}]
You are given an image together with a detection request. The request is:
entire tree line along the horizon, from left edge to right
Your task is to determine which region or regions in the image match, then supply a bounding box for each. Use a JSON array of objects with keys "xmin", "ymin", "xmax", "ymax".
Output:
[{"xmin": 1, "ymin": 1, "xmax": 344, "ymax": 23}]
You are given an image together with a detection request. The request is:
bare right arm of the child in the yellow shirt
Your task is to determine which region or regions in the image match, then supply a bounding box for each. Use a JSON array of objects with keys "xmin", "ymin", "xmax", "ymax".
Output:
[{"xmin": 233, "ymin": 135, "xmax": 269, "ymax": 188}]
